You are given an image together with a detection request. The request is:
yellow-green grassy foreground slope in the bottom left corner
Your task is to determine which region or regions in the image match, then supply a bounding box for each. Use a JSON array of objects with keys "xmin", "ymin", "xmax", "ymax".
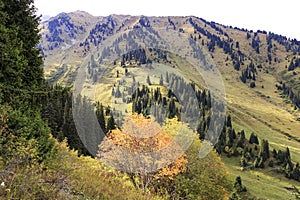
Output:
[{"xmin": 0, "ymin": 134, "xmax": 162, "ymax": 199}]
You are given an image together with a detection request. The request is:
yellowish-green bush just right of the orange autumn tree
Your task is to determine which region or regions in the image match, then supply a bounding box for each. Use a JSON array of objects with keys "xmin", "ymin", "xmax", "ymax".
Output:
[{"xmin": 157, "ymin": 138, "xmax": 232, "ymax": 199}]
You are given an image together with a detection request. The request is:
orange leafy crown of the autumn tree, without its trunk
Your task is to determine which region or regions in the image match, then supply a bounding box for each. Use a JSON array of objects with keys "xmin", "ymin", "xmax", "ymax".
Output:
[{"xmin": 98, "ymin": 114, "xmax": 187, "ymax": 179}]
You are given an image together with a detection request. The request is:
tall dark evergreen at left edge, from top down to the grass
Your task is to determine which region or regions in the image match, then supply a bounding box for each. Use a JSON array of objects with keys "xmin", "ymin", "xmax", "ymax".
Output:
[{"xmin": 0, "ymin": 0, "xmax": 59, "ymax": 161}]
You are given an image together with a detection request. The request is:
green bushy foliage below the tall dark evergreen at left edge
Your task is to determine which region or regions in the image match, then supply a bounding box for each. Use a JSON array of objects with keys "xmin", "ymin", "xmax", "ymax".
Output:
[{"xmin": 1, "ymin": 105, "xmax": 55, "ymax": 161}]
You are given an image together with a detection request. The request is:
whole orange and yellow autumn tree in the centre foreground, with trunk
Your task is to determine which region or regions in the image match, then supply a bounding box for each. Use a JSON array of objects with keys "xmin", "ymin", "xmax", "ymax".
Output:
[{"xmin": 97, "ymin": 114, "xmax": 192, "ymax": 190}]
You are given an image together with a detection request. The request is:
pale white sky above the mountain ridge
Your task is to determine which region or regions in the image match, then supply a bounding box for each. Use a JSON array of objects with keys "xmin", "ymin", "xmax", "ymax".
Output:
[{"xmin": 35, "ymin": 0, "xmax": 300, "ymax": 40}]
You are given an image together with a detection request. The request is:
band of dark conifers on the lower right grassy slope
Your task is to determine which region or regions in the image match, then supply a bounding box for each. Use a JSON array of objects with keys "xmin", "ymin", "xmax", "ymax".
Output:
[{"xmin": 215, "ymin": 117, "xmax": 300, "ymax": 181}]
